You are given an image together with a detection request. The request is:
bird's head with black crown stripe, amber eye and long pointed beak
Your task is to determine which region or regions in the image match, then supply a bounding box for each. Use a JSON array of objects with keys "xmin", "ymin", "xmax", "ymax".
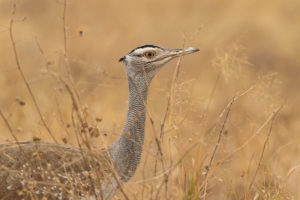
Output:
[{"xmin": 119, "ymin": 45, "xmax": 199, "ymax": 80}]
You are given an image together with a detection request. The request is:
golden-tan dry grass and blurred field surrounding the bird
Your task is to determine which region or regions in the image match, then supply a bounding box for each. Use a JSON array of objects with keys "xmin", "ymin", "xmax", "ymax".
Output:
[{"xmin": 0, "ymin": 0, "xmax": 300, "ymax": 200}]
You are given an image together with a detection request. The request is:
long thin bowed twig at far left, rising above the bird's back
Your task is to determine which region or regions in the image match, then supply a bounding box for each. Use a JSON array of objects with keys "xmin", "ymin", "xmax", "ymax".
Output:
[{"xmin": 9, "ymin": 5, "xmax": 58, "ymax": 143}]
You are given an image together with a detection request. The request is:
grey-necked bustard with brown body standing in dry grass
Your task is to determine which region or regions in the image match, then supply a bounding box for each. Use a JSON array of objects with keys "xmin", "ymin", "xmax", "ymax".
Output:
[{"xmin": 0, "ymin": 45, "xmax": 199, "ymax": 199}]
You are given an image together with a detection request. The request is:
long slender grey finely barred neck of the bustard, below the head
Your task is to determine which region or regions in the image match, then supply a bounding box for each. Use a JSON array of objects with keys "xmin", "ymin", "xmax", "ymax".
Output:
[{"xmin": 110, "ymin": 76, "xmax": 150, "ymax": 181}]
